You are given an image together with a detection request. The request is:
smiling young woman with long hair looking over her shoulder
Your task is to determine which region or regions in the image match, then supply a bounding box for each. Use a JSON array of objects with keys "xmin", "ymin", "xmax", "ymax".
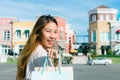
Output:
[{"xmin": 16, "ymin": 15, "xmax": 58, "ymax": 80}]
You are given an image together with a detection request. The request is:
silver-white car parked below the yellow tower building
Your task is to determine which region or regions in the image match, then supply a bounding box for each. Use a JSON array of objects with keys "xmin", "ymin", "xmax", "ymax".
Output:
[{"xmin": 88, "ymin": 57, "xmax": 112, "ymax": 65}]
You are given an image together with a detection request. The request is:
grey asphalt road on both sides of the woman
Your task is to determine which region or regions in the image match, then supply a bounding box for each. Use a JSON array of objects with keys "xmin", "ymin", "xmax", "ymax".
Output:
[{"xmin": 0, "ymin": 64, "xmax": 120, "ymax": 80}]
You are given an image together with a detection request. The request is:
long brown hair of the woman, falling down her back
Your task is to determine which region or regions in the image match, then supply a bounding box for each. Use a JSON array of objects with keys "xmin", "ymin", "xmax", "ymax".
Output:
[{"xmin": 16, "ymin": 15, "xmax": 58, "ymax": 80}]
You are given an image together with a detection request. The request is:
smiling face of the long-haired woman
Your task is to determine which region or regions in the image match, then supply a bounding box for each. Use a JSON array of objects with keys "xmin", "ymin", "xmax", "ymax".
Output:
[{"xmin": 40, "ymin": 22, "xmax": 57, "ymax": 49}]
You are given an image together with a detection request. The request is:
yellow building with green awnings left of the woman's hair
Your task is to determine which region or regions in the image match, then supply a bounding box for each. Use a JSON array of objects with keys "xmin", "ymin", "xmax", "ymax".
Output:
[{"xmin": 12, "ymin": 20, "xmax": 35, "ymax": 54}]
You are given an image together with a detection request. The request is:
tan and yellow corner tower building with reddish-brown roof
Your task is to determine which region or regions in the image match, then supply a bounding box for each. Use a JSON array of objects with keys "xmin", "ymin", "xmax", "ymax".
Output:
[{"xmin": 88, "ymin": 5, "xmax": 118, "ymax": 55}]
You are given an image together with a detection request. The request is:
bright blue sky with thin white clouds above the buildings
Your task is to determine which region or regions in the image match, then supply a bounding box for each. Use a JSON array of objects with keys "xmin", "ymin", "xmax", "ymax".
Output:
[{"xmin": 0, "ymin": 0, "xmax": 120, "ymax": 42}]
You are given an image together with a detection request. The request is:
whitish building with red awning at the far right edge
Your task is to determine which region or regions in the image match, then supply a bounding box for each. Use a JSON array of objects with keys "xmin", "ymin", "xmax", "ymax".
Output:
[{"xmin": 110, "ymin": 21, "xmax": 120, "ymax": 55}]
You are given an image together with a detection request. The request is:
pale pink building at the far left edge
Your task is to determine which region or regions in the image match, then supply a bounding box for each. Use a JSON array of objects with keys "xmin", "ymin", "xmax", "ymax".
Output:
[{"xmin": 0, "ymin": 17, "xmax": 16, "ymax": 55}]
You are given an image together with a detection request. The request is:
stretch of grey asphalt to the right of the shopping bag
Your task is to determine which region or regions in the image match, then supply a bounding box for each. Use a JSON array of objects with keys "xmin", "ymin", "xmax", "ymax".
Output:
[{"xmin": 64, "ymin": 64, "xmax": 120, "ymax": 80}]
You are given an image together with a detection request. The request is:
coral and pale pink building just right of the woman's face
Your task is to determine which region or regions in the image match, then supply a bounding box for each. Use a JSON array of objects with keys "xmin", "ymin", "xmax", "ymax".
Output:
[{"xmin": 55, "ymin": 16, "xmax": 75, "ymax": 53}]
